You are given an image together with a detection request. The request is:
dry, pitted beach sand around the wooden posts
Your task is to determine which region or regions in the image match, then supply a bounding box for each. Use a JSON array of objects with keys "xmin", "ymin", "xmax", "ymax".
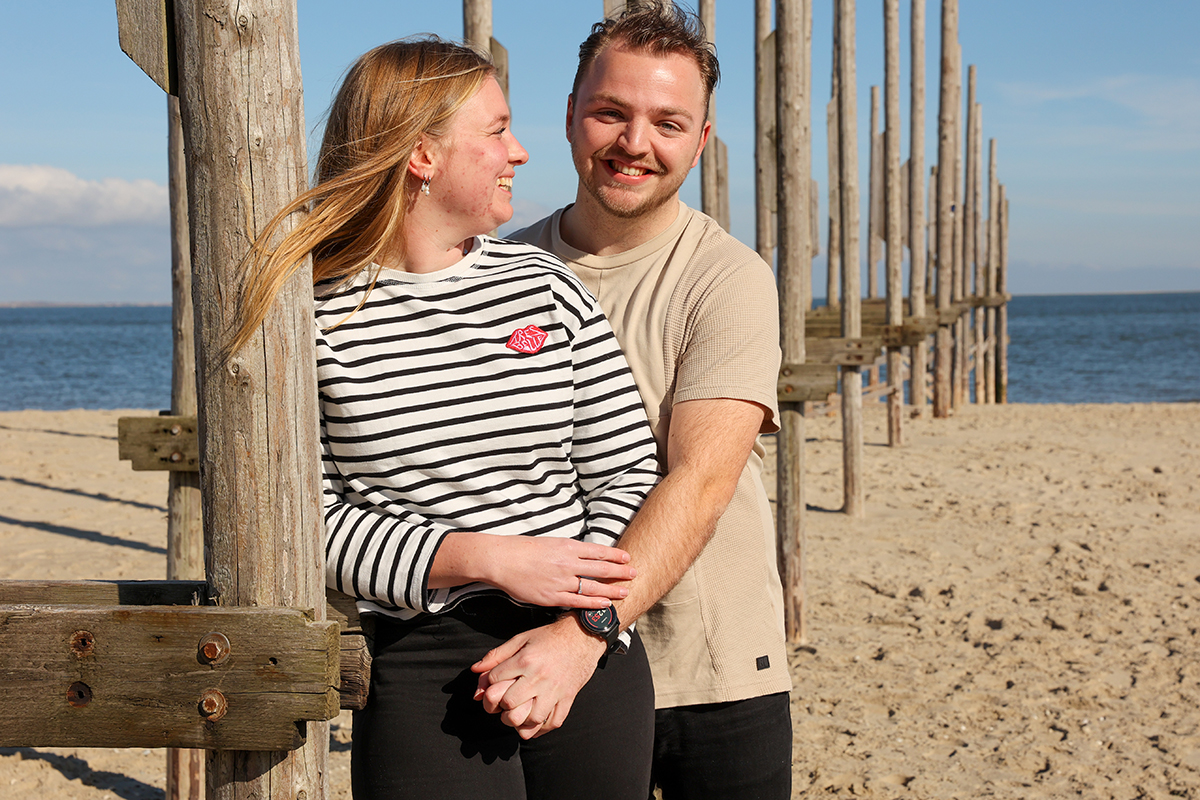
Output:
[{"xmin": 0, "ymin": 404, "xmax": 1200, "ymax": 800}]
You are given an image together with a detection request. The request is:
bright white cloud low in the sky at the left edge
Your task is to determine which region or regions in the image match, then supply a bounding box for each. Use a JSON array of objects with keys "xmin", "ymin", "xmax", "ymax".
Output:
[{"xmin": 0, "ymin": 164, "xmax": 168, "ymax": 228}]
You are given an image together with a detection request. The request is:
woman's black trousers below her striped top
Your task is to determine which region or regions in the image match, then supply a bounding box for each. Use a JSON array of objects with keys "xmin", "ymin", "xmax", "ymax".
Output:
[{"xmin": 350, "ymin": 597, "xmax": 654, "ymax": 800}]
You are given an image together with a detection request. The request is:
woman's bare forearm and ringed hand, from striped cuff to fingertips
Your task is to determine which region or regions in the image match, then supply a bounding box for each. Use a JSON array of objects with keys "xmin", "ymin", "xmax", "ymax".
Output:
[{"xmin": 428, "ymin": 534, "xmax": 637, "ymax": 608}]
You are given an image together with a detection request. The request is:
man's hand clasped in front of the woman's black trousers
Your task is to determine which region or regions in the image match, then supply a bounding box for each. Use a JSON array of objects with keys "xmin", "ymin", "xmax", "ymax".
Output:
[{"xmin": 472, "ymin": 614, "xmax": 605, "ymax": 739}]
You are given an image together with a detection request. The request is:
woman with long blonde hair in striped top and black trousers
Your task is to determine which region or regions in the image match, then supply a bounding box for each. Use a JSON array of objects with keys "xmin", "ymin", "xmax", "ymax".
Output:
[{"xmin": 232, "ymin": 38, "xmax": 658, "ymax": 800}]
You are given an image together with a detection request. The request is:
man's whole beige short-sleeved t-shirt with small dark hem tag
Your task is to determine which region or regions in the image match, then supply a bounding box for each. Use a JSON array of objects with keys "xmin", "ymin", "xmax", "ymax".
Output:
[{"xmin": 514, "ymin": 203, "xmax": 792, "ymax": 708}]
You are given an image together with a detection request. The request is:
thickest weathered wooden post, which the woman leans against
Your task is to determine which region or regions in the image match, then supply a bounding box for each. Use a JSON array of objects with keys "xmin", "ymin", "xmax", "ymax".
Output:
[{"xmin": 174, "ymin": 0, "xmax": 329, "ymax": 800}]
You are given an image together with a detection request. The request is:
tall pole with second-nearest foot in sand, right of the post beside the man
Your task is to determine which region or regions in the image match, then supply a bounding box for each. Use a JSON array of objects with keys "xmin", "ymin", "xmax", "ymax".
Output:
[{"xmin": 838, "ymin": 0, "xmax": 865, "ymax": 517}]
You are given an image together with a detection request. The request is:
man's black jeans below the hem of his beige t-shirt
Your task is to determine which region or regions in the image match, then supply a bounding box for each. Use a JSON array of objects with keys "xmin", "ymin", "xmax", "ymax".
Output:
[{"xmin": 652, "ymin": 692, "xmax": 792, "ymax": 800}]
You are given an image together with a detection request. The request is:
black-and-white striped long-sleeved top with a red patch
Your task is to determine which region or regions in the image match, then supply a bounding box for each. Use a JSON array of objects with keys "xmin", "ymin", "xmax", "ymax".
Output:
[{"xmin": 316, "ymin": 236, "xmax": 659, "ymax": 619}]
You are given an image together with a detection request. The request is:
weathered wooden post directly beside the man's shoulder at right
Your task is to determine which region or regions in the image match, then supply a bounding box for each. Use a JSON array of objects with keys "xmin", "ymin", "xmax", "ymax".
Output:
[{"xmin": 775, "ymin": 0, "xmax": 812, "ymax": 642}]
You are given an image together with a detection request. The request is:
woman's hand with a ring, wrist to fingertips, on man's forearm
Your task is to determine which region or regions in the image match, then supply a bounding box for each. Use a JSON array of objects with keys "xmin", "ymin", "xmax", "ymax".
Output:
[{"xmin": 484, "ymin": 536, "xmax": 637, "ymax": 609}]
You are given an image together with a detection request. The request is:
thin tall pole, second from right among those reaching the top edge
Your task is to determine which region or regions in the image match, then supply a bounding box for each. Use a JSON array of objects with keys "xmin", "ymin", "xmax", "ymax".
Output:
[{"xmin": 908, "ymin": 0, "xmax": 929, "ymax": 414}]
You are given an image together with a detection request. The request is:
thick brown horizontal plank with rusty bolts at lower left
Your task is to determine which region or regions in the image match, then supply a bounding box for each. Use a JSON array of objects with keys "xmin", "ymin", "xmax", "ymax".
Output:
[{"xmin": 0, "ymin": 606, "xmax": 338, "ymax": 751}]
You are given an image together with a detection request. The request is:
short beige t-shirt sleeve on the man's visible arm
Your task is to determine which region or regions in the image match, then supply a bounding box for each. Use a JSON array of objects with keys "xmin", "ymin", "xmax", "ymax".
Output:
[{"xmin": 667, "ymin": 245, "xmax": 781, "ymax": 433}]
